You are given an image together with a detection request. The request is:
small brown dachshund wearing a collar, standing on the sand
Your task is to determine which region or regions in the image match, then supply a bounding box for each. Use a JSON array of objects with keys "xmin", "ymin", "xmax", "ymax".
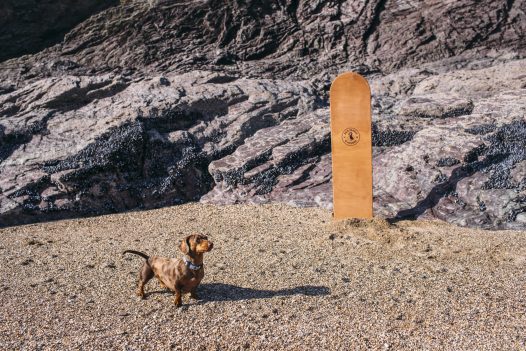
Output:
[{"xmin": 123, "ymin": 234, "xmax": 214, "ymax": 307}]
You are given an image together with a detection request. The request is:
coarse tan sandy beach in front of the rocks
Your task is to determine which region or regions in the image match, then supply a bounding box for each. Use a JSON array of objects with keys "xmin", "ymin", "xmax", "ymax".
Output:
[{"xmin": 0, "ymin": 204, "xmax": 526, "ymax": 350}]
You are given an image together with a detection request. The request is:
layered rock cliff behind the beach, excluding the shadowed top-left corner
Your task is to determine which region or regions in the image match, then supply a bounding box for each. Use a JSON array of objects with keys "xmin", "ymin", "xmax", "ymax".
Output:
[{"xmin": 0, "ymin": 0, "xmax": 526, "ymax": 228}]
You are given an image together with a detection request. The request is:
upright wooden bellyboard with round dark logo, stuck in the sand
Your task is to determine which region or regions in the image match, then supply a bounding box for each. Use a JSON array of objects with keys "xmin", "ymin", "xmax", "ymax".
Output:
[{"xmin": 330, "ymin": 73, "xmax": 373, "ymax": 219}]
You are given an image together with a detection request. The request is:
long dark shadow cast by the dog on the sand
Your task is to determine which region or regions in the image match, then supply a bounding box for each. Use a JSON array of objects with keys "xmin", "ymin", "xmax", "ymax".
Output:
[{"xmin": 148, "ymin": 283, "xmax": 331, "ymax": 303}]
